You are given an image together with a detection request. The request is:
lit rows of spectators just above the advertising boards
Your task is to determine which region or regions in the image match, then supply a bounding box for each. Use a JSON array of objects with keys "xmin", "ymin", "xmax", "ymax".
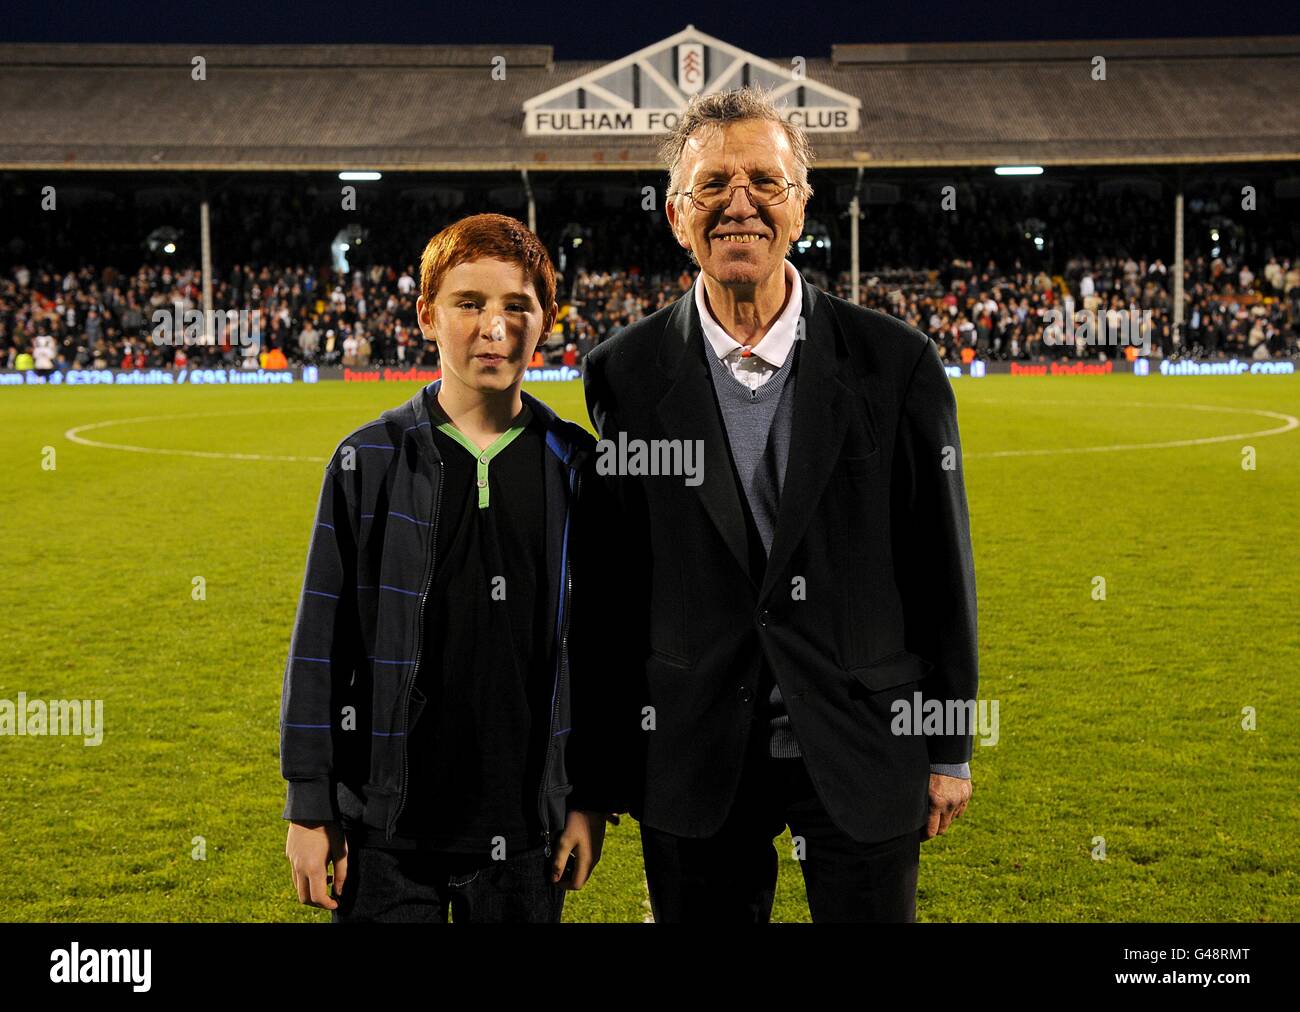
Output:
[{"xmin": 0, "ymin": 247, "xmax": 1300, "ymax": 369}]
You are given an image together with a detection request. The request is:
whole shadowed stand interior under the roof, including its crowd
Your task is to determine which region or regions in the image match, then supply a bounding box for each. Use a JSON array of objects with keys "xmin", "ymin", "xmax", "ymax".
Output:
[{"xmin": 0, "ymin": 177, "xmax": 1300, "ymax": 368}]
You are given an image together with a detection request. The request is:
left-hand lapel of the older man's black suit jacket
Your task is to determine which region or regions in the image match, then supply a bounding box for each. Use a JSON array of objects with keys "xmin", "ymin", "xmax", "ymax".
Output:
[{"xmin": 657, "ymin": 278, "xmax": 753, "ymax": 581}]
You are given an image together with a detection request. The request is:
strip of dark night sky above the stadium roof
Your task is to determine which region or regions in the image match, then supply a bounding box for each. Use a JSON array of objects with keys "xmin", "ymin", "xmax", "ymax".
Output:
[{"xmin": 0, "ymin": 0, "xmax": 1300, "ymax": 60}]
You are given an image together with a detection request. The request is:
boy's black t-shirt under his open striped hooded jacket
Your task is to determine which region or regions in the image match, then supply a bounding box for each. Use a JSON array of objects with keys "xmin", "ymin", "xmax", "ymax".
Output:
[{"xmin": 345, "ymin": 397, "xmax": 562, "ymax": 859}]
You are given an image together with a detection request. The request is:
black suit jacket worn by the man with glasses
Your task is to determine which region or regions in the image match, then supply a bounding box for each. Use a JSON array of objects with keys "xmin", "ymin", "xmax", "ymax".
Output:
[{"xmin": 575, "ymin": 271, "xmax": 978, "ymax": 842}]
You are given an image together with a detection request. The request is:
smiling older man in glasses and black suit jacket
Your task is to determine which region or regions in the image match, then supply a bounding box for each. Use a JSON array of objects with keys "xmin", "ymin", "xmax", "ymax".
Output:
[{"xmin": 577, "ymin": 90, "xmax": 978, "ymax": 922}]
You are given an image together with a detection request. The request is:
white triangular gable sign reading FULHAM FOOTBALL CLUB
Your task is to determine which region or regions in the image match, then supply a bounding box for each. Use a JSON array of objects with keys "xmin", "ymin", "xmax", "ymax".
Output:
[{"xmin": 524, "ymin": 25, "xmax": 862, "ymax": 135}]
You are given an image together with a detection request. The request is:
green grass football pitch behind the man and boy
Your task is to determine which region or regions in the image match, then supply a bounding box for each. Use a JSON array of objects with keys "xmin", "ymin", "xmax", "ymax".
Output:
[{"xmin": 0, "ymin": 376, "xmax": 1300, "ymax": 921}]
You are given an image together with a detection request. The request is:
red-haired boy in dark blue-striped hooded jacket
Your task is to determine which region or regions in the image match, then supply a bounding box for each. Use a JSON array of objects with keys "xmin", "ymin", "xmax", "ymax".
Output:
[{"xmin": 281, "ymin": 215, "xmax": 619, "ymax": 922}]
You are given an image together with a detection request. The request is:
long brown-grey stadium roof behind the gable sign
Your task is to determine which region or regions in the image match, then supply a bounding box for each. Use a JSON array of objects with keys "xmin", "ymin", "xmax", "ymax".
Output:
[{"xmin": 0, "ymin": 27, "xmax": 1300, "ymax": 172}]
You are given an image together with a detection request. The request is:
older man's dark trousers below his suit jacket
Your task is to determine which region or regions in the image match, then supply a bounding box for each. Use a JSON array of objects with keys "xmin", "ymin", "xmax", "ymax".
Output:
[{"xmin": 641, "ymin": 725, "xmax": 924, "ymax": 924}]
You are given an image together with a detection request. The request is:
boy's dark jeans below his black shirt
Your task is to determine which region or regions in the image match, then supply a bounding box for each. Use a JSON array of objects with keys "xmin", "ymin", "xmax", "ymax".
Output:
[{"xmin": 330, "ymin": 840, "xmax": 564, "ymax": 924}]
